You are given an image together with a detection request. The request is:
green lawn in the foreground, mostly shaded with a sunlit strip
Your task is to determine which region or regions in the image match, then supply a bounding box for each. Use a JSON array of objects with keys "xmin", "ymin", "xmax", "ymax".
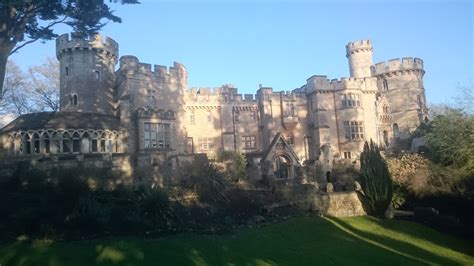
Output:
[{"xmin": 0, "ymin": 217, "xmax": 474, "ymax": 266}]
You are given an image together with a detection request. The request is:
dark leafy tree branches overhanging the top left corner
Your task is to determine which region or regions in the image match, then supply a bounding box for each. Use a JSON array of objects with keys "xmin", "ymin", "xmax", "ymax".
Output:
[{"xmin": 0, "ymin": 0, "xmax": 139, "ymax": 95}]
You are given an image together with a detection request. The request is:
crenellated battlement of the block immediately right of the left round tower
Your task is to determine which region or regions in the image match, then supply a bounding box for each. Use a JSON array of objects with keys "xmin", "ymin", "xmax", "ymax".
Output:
[{"xmin": 118, "ymin": 55, "xmax": 188, "ymax": 82}]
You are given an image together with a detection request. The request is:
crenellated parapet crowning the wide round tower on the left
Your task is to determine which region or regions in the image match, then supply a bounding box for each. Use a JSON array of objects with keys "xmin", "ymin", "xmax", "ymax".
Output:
[{"xmin": 56, "ymin": 33, "xmax": 119, "ymax": 58}]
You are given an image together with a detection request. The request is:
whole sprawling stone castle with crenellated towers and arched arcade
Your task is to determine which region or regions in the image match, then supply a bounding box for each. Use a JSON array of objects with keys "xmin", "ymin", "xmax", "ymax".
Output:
[{"xmin": 0, "ymin": 34, "xmax": 427, "ymax": 179}]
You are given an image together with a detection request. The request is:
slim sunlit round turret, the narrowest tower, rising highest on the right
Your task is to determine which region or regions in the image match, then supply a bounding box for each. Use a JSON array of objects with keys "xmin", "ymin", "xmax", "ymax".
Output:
[{"xmin": 346, "ymin": 40, "xmax": 373, "ymax": 78}]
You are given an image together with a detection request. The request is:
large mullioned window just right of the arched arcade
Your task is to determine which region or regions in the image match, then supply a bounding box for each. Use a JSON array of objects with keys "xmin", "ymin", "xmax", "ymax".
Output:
[{"xmin": 144, "ymin": 123, "xmax": 171, "ymax": 149}]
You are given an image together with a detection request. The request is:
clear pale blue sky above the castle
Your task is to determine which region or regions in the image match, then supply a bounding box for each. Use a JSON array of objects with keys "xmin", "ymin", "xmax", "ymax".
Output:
[{"xmin": 11, "ymin": 0, "xmax": 474, "ymax": 103}]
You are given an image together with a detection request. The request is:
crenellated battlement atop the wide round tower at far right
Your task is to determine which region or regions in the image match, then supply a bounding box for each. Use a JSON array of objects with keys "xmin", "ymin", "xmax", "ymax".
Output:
[{"xmin": 371, "ymin": 57, "xmax": 424, "ymax": 76}]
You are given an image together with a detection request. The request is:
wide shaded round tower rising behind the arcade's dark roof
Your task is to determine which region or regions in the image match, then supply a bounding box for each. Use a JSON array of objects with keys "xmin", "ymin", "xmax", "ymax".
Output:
[{"xmin": 56, "ymin": 33, "xmax": 118, "ymax": 115}]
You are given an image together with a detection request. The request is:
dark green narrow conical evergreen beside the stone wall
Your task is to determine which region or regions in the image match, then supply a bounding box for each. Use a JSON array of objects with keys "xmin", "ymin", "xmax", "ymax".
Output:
[{"xmin": 360, "ymin": 140, "xmax": 393, "ymax": 216}]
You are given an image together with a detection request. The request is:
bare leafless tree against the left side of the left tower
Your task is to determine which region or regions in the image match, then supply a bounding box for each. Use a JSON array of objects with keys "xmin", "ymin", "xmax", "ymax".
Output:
[{"xmin": 28, "ymin": 57, "xmax": 59, "ymax": 111}]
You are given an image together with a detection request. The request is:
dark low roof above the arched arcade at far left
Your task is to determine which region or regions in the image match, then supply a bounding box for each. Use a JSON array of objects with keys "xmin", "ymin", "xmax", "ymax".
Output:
[{"xmin": 0, "ymin": 112, "xmax": 120, "ymax": 132}]
